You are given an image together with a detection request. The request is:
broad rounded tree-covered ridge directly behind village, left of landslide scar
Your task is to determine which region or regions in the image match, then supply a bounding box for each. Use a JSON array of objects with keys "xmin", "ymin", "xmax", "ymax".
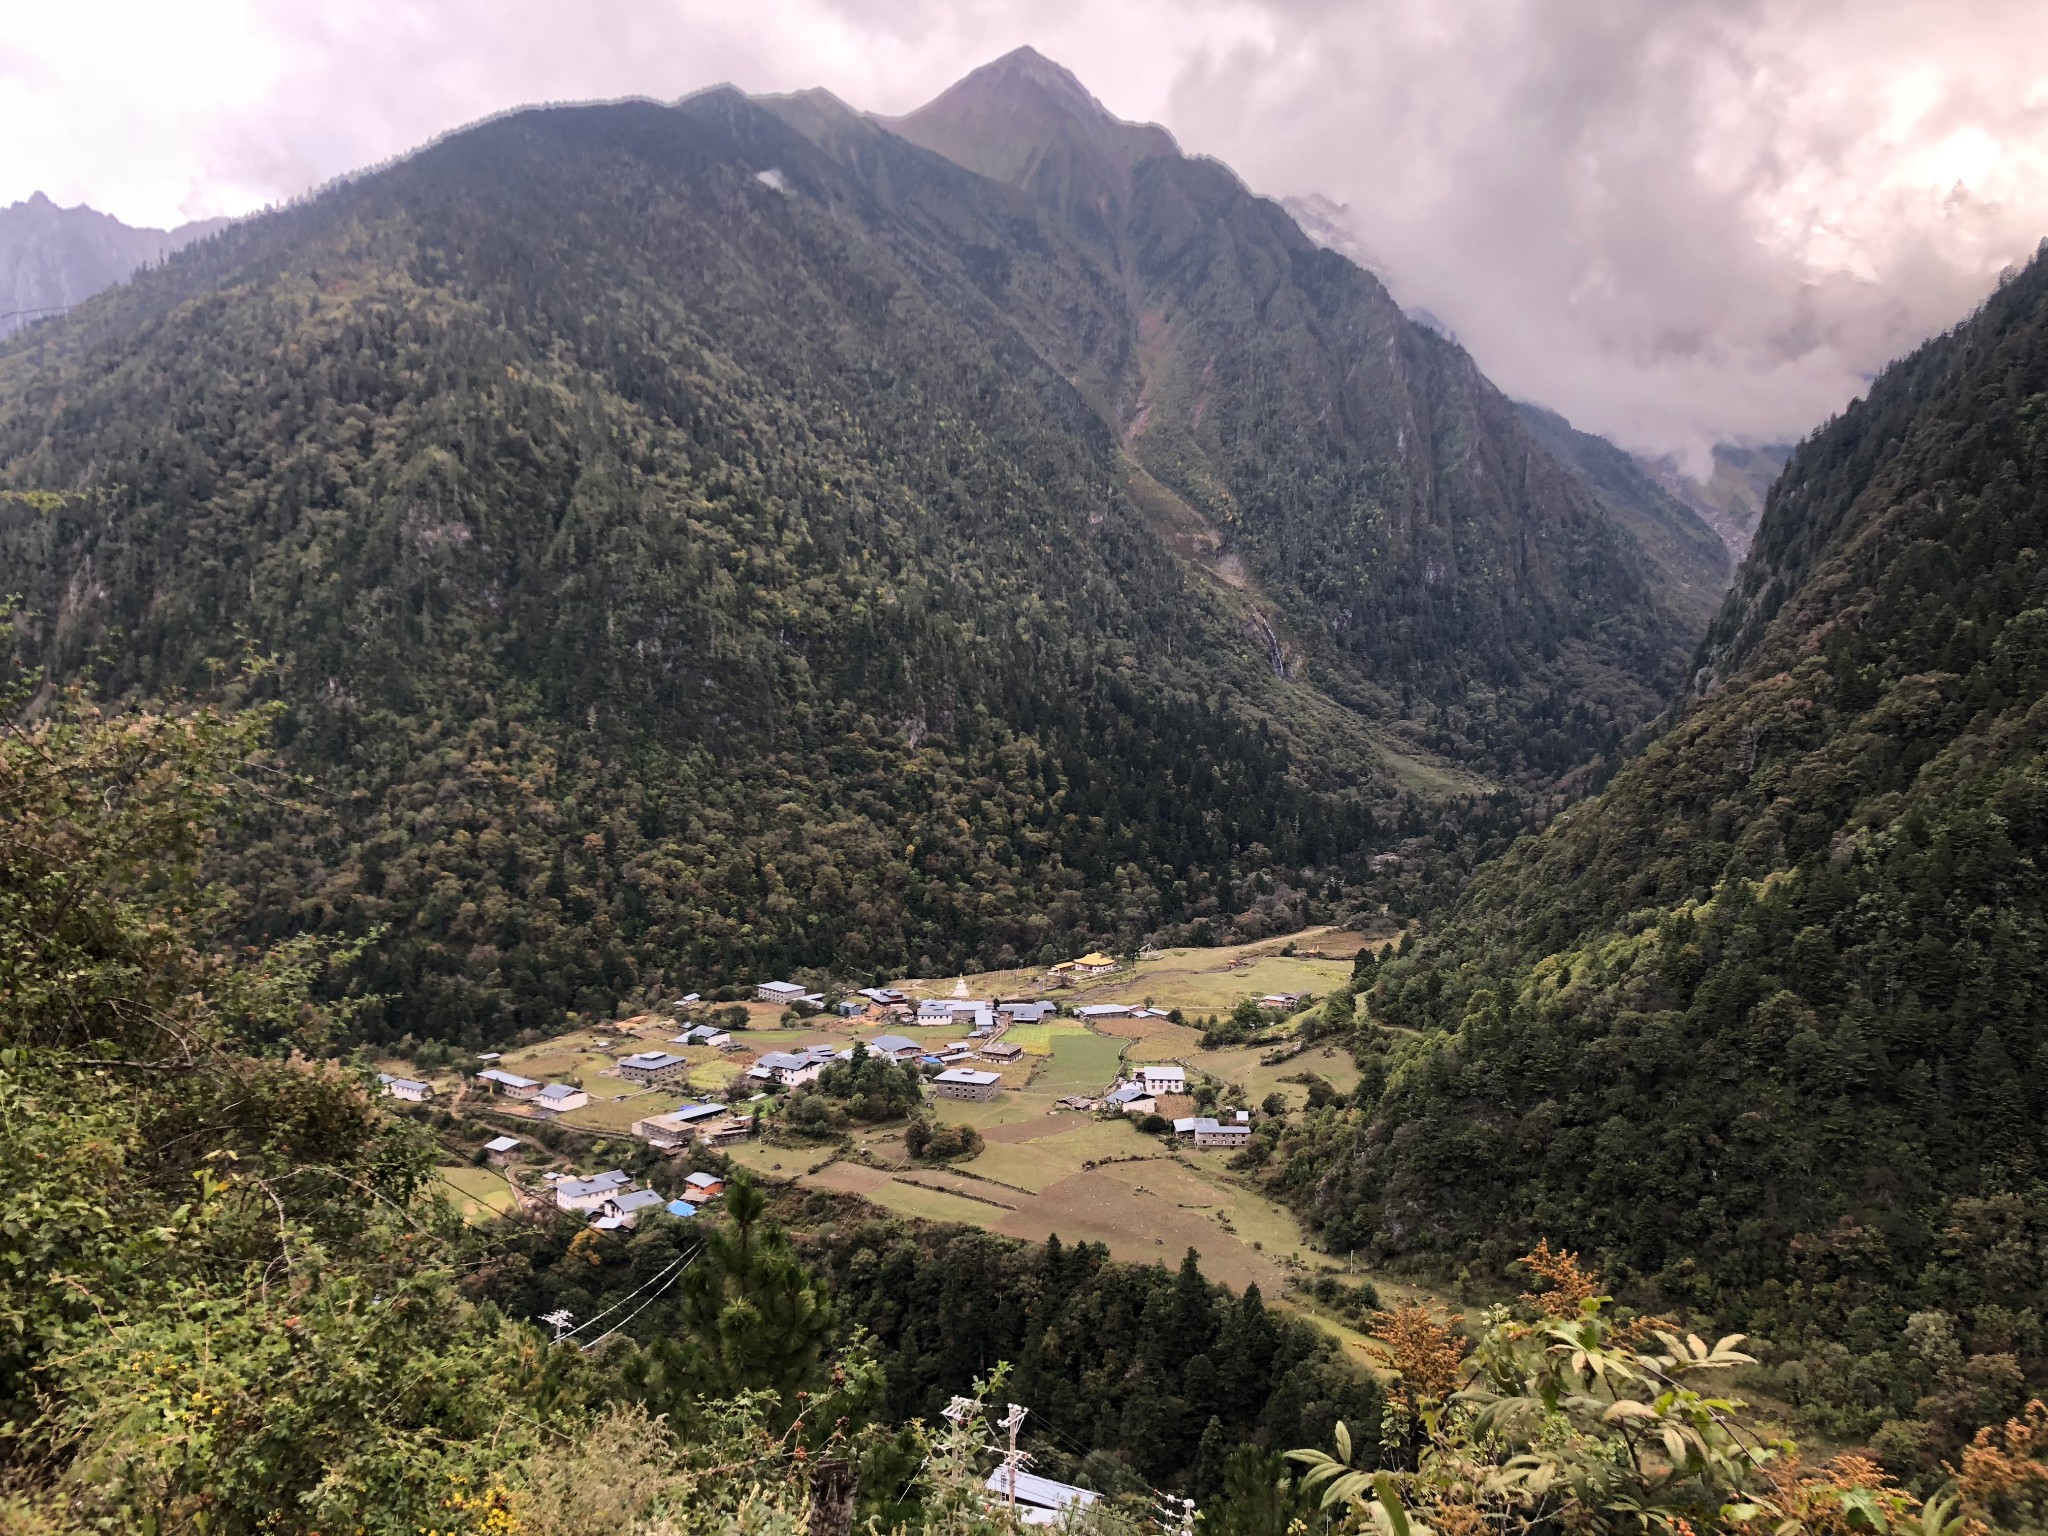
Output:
[{"xmin": 0, "ymin": 92, "xmax": 1403, "ymax": 1042}]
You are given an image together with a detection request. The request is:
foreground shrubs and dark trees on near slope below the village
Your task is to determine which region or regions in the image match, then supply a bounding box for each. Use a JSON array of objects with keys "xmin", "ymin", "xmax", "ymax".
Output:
[{"xmin": 0, "ymin": 680, "xmax": 2015, "ymax": 1536}]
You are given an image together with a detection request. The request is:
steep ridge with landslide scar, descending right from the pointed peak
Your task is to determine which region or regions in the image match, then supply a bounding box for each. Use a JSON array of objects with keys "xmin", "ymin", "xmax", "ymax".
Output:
[{"xmin": 835, "ymin": 49, "xmax": 1700, "ymax": 782}]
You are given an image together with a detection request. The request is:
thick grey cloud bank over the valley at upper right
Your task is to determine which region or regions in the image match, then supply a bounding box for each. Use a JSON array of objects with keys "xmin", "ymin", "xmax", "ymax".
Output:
[{"xmin": 1167, "ymin": 0, "xmax": 2048, "ymax": 465}]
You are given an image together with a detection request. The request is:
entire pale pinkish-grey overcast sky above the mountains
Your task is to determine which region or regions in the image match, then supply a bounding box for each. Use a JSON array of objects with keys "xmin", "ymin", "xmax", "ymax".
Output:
[{"xmin": 0, "ymin": 0, "xmax": 2048, "ymax": 463}]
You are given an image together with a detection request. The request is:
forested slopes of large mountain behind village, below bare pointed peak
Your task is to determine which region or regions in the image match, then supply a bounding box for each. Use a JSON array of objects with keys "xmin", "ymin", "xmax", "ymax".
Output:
[{"xmin": 0, "ymin": 57, "xmax": 1683, "ymax": 1044}]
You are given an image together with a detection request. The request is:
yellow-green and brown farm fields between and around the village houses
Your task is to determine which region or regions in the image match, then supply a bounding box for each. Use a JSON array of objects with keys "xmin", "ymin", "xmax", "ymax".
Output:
[{"xmin": 411, "ymin": 930, "xmax": 1458, "ymax": 1364}]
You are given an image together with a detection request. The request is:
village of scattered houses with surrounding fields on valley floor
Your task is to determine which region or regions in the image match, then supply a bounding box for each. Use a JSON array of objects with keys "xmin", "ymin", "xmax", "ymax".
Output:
[{"xmin": 381, "ymin": 932, "xmax": 1384, "ymax": 1318}]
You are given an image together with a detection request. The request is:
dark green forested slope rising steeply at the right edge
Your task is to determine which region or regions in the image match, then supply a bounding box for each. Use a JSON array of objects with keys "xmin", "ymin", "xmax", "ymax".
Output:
[{"xmin": 1282, "ymin": 260, "xmax": 2048, "ymax": 1454}]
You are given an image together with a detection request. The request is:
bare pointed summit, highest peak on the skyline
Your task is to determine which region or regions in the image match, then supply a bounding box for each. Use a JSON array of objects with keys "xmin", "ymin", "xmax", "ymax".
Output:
[{"xmin": 879, "ymin": 45, "xmax": 1180, "ymax": 184}]
